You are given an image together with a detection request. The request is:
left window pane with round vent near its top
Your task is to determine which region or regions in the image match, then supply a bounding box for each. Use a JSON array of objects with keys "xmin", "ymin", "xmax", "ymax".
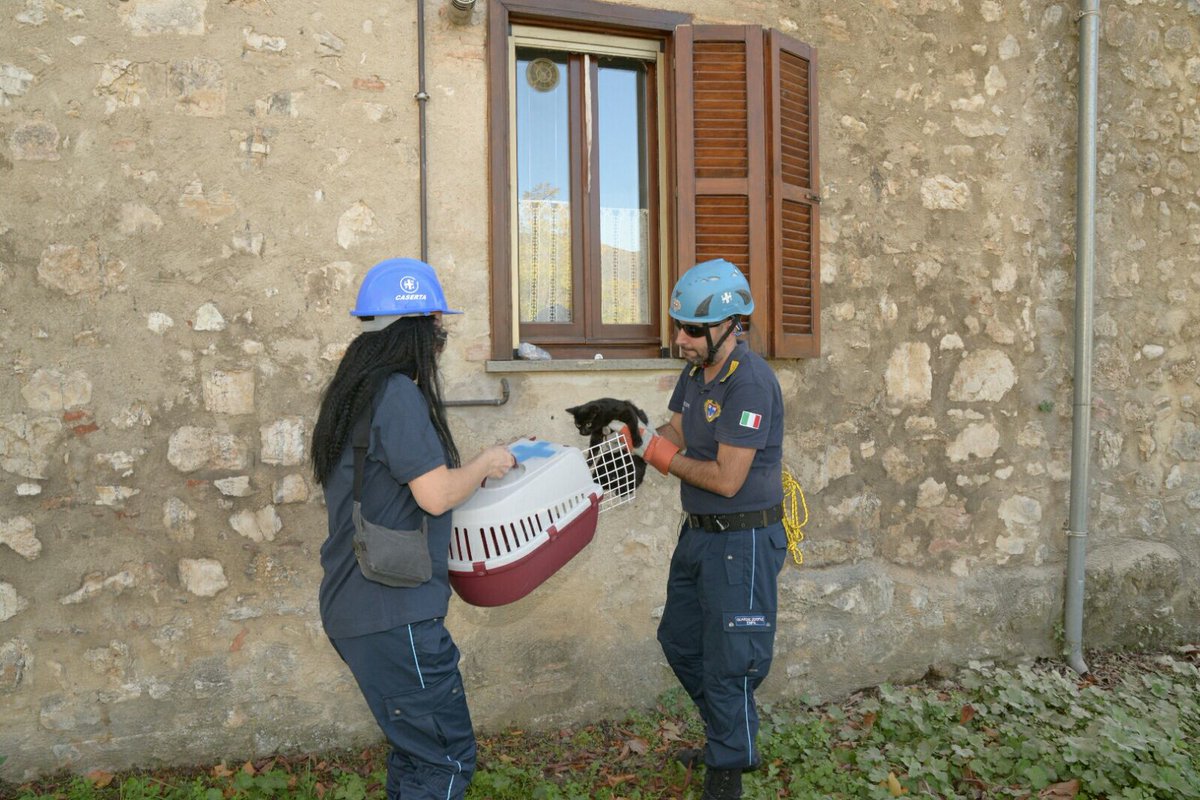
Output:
[{"xmin": 516, "ymin": 50, "xmax": 574, "ymax": 323}]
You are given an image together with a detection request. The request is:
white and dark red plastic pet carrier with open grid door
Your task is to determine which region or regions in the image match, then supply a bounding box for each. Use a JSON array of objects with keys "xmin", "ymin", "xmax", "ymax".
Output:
[{"xmin": 449, "ymin": 439, "xmax": 635, "ymax": 606}]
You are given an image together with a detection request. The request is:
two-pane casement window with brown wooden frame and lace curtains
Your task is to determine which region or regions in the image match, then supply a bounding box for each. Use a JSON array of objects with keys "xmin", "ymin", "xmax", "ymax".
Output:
[{"xmin": 509, "ymin": 31, "xmax": 661, "ymax": 357}]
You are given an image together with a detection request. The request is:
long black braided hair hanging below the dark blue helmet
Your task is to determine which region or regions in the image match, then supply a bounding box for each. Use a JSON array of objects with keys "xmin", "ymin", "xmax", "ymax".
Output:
[{"xmin": 312, "ymin": 317, "xmax": 461, "ymax": 486}]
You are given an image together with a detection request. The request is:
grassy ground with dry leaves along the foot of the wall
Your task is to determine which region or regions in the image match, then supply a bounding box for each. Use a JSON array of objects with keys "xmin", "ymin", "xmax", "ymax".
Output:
[{"xmin": 0, "ymin": 645, "xmax": 1200, "ymax": 800}]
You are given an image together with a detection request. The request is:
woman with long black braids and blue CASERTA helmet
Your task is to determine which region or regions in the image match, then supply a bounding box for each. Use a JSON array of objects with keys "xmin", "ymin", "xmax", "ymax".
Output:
[{"xmin": 312, "ymin": 259, "xmax": 515, "ymax": 800}]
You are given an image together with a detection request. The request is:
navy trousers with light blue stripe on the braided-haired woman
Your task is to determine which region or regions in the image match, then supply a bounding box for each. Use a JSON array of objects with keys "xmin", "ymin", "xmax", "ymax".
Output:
[{"xmin": 332, "ymin": 618, "xmax": 475, "ymax": 800}]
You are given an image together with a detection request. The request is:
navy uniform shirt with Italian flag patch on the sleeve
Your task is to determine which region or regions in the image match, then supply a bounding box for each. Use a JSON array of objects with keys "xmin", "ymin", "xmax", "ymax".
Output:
[{"xmin": 667, "ymin": 342, "xmax": 784, "ymax": 513}]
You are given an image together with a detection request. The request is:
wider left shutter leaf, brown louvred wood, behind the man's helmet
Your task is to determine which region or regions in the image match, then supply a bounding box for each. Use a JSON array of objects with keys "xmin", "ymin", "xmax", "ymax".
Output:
[{"xmin": 673, "ymin": 25, "xmax": 770, "ymax": 354}]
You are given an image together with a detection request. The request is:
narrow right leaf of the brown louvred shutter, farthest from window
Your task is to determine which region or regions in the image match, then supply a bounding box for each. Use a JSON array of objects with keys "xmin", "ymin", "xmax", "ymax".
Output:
[{"xmin": 766, "ymin": 30, "xmax": 821, "ymax": 359}]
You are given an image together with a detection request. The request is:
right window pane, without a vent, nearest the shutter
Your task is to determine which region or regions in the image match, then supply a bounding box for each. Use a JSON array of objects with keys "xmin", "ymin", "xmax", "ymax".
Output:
[{"xmin": 596, "ymin": 58, "xmax": 650, "ymax": 325}]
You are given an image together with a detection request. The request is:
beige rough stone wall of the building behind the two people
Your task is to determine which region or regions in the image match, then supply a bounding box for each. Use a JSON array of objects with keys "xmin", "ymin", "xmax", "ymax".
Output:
[{"xmin": 0, "ymin": 0, "xmax": 1200, "ymax": 778}]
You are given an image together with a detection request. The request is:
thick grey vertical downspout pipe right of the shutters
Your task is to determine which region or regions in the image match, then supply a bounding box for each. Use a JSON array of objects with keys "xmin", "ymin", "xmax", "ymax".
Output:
[{"xmin": 1063, "ymin": 0, "xmax": 1100, "ymax": 675}]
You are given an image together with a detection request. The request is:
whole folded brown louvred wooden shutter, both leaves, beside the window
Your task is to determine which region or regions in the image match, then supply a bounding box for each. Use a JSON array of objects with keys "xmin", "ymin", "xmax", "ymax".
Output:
[{"xmin": 672, "ymin": 25, "xmax": 821, "ymax": 357}]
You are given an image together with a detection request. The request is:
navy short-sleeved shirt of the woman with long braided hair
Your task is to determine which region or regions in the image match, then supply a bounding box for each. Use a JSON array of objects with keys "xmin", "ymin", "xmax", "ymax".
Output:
[{"xmin": 320, "ymin": 373, "xmax": 450, "ymax": 639}]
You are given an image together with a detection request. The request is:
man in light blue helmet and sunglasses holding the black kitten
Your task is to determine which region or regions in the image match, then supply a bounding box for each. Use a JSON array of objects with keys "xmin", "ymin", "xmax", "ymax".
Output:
[{"xmin": 631, "ymin": 259, "xmax": 787, "ymax": 800}]
